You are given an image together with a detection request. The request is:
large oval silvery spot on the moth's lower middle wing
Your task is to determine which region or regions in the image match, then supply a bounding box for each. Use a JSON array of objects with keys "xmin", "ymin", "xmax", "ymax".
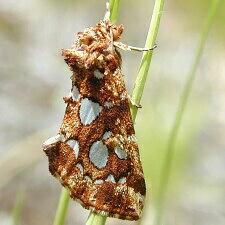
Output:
[{"xmin": 89, "ymin": 141, "xmax": 109, "ymax": 169}]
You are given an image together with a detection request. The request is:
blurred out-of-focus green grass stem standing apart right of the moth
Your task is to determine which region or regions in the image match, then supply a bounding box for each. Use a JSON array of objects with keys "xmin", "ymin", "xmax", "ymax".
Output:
[{"xmin": 153, "ymin": 0, "xmax": 222, "ymax": 225}]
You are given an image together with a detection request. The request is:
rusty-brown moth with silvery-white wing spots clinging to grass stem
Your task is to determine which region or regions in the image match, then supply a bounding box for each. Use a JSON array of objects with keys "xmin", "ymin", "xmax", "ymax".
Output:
[{"xmin": 43, "ymin": 4, "xmax": 146, "ymax": 220}]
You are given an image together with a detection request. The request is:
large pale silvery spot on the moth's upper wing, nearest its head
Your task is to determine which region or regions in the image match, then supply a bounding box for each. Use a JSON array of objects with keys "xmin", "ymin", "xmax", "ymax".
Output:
[{"xmin": 80, "ymin": 98, "xmax": 102, "ymax": 125}]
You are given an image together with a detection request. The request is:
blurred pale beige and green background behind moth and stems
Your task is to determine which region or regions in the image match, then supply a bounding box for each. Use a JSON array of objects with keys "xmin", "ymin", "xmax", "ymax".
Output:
[{"xmin": 0, "ymin": 0, "xmax": 225, "ymax": 225}]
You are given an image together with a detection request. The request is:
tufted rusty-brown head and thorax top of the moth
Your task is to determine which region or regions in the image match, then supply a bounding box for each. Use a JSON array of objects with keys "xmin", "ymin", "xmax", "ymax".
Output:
[{"xmin": 63, "ymin": 21, "xmax": 123, "ymax": 71}]
